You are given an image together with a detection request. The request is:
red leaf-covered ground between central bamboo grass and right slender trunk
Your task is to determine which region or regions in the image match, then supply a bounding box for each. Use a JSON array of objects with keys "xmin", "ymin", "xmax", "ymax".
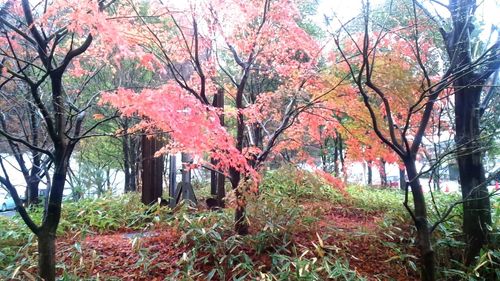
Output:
[{"xmin": 304, "ymin": 202, "xmax": 419, "ymax": 281}]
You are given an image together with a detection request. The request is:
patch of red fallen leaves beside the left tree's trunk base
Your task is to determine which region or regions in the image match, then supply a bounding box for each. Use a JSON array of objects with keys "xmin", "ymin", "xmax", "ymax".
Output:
[{"xmin": 58, "ymin": 229, "xmax": 186, "ymax": 281}]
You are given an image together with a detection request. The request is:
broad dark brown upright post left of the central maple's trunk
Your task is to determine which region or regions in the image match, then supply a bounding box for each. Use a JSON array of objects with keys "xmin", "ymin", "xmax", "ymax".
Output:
[{"xmin": 141, "ymin": 135, "xmax": 164, "ymax": 205}]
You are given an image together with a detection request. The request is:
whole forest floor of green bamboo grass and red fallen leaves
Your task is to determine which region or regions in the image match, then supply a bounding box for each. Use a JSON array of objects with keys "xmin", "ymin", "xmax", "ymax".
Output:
[{"xmin": 0, "ymin": 167, "xmax": 498, "ymax": 280}]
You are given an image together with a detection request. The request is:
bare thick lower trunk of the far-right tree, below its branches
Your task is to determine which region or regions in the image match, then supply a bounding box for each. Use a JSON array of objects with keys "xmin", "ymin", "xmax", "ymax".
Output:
[{"xmin": 455, "ymin": 86, "xmax": 491, "ymax": 265}]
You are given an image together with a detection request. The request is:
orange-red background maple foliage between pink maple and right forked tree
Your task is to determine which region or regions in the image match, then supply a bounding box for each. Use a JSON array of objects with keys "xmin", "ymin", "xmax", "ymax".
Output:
[{"xmin": 277, "ymin": 70, "xmax": 398, "ymax": 184}]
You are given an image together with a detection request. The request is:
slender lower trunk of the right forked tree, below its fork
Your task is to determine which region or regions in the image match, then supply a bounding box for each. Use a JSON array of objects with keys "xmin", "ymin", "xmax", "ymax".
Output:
[{"xmin": 405, "ymin": 159, "xmax": 436, "ymax": 281}]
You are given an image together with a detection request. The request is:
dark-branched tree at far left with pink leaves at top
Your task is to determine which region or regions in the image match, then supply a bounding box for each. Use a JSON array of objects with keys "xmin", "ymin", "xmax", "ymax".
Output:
[{"xmin": 0, "ymin": 0, "xmax": 127, "ymax": 281}]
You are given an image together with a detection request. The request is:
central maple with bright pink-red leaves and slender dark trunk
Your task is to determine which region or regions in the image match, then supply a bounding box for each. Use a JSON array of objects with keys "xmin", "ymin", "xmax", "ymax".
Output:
[{"xmin": 103, "ymin": 1, "xmax": 332, "ymax": 234}]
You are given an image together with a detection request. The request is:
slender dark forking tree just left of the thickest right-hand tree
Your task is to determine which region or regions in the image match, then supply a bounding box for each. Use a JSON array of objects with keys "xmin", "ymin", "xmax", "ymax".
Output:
[{"xmin": 334, "ymin": 1, "xmax": 478, "ymax": 280}]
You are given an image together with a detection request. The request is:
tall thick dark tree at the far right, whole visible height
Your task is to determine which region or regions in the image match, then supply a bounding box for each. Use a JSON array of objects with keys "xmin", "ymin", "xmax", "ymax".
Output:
[{"xmin": 432, "ymin": 0, "xmax": 500, "ymax": 265}]
